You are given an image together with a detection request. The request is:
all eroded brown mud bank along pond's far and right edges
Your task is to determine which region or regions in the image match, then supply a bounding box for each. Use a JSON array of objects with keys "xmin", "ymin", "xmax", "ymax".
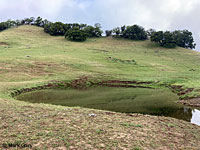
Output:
[{"xmin": 11, "ymin": 76, "xmax": 200, "ymax": 107}]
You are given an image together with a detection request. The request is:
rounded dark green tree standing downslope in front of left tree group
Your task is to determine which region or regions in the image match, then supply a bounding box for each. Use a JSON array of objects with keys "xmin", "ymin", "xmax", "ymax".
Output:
[{"xmin": 65, "ymin": 27, "xmax": 87, "ymax": 42}]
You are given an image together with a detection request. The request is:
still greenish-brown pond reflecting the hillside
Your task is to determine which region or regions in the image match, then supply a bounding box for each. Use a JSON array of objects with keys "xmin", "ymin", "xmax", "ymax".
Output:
[{"xmin": 17, "ymin": 86, "xmax": 200, "ymax": 125}]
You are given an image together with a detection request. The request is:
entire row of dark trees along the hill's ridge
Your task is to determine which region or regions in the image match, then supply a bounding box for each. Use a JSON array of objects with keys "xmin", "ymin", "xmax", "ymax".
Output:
[{"xmin": 0, "ymin": 17, "xmax": 196, "ymax": 49}]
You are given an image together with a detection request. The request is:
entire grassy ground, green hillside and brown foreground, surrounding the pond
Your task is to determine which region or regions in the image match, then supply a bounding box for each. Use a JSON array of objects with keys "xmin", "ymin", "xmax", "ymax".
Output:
[{"xmin": 0, "ymin": 26, "xmax": 200, "ymax": 149}]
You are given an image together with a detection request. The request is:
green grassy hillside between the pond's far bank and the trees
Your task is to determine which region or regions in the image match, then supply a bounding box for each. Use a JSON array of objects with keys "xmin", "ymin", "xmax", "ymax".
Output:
[{"xmin": 0, "ymin": 26, "xmax": 200, "ymax": 93}]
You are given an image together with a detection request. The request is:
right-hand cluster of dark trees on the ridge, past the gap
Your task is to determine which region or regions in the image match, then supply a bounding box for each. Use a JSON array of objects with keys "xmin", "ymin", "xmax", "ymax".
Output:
[{"xmin": 105, "ymin": 25, "xmax": 196, "ymax": 49}]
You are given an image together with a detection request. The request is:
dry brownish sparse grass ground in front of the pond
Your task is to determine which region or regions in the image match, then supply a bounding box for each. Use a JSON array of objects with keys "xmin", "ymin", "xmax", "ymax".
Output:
[{"xmin": 0, "ymin": 99, "xmax": 200, "ymax": 150}]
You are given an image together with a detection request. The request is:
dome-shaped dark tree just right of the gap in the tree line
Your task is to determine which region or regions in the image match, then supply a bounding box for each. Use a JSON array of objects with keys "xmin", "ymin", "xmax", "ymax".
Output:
[{"xmin": 122, "ymin": 25, "xmax": 147, "ymax": 40}]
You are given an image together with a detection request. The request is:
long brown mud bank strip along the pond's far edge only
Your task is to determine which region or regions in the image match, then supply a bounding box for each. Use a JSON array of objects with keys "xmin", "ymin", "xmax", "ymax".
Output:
[{"xmin": 11, "ymin": 76, "xmax": 153, "ymax": 97}]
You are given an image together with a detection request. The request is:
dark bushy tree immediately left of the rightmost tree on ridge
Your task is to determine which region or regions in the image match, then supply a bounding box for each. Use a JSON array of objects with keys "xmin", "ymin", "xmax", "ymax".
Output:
[{"xmin": 151, "ymin": 31, "xmax": 176, "ymax": 48}]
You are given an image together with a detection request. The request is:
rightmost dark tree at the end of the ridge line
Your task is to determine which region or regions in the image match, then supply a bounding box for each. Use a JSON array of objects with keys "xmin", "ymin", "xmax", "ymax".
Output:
[{"xmin": 173, "ymin": 30, "xmax": 196, "ymax": 49}]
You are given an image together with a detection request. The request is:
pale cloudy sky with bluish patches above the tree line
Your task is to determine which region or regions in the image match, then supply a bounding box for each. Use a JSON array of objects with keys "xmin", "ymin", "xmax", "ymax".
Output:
[{"xmin": 0, "ymin": 0, "xmax": 200, "ymax": 50}]
